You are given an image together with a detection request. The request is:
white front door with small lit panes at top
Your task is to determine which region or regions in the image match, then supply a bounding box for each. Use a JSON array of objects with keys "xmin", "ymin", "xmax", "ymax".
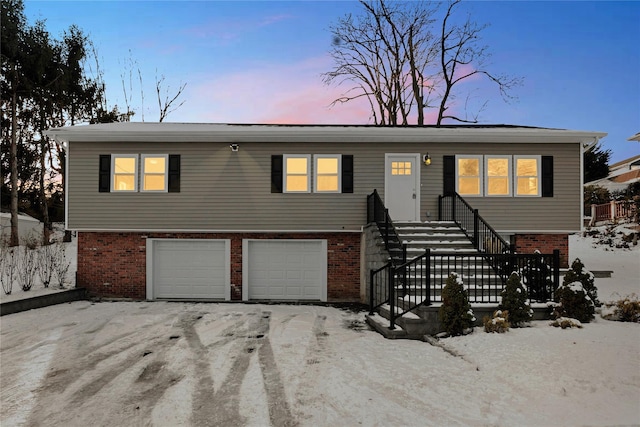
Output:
[{"xmin": 384, "ymin": 154, "xmax": 420, "ymax": 221}]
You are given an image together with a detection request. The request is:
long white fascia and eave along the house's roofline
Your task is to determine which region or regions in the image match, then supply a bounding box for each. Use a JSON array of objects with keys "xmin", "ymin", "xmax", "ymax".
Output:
[{"xmin": 45, "ymin": 123, "xmax": 607, "ymax": 146}]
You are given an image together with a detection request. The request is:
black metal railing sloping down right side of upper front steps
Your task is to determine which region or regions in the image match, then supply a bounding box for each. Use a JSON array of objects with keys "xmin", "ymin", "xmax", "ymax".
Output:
[{"xmin": 438, "ymin": 192, "xmax": 514, "ymax": 254}]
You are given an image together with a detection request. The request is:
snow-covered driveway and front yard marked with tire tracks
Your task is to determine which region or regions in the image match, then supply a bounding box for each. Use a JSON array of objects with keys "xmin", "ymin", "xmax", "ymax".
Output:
[{"xmin": 0, "ymin": 226, "xmax": 640, "ymax": 427}]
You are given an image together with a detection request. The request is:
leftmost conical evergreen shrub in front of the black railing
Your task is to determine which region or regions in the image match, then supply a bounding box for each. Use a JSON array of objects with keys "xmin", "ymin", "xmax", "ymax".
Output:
[{"xmin": 438, "ymin": 273, "xmax": 476, "ymax": 336}]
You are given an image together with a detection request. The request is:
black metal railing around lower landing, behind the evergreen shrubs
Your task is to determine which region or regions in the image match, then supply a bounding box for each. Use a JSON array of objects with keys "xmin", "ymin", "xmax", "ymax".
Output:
[{"xmin": 370, "ymin": 249, "xmax": 560, "ymax": 329}]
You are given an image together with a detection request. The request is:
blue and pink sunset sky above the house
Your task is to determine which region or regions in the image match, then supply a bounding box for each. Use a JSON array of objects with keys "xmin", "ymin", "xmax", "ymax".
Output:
[{"xmin": 25, "ymin": 0, "xmax": 640, "ymax": 162}]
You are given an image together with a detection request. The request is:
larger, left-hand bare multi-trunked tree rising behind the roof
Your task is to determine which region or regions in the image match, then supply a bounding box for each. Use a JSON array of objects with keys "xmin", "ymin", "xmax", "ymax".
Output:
[{"xmin": 323, "ymin": 0, "xmax": 435, "ymax": 125}]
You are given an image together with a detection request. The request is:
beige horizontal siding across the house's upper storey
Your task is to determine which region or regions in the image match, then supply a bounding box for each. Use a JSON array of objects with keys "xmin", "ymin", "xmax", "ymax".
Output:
[{"xmin": 67, "ymin": 141, "xmax": 580, "ymax": 231}]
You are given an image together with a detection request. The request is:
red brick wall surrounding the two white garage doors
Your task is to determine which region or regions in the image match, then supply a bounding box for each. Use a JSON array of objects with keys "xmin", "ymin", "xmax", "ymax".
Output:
[{"xmin": 77, "ymin": 232, "xmax": 360, "ymax": 301}]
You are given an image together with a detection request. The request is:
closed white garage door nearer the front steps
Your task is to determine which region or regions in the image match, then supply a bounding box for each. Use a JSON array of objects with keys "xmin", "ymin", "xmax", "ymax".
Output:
[{"xmin": 242, "ymin": 240, "xmax": 327, "ymax": 301}]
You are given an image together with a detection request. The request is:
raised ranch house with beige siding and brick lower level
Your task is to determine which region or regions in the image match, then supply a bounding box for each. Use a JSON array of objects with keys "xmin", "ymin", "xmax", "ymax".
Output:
[{"xmin": 47, "ymin": 123, "xmax": 606, "ymax": 301}]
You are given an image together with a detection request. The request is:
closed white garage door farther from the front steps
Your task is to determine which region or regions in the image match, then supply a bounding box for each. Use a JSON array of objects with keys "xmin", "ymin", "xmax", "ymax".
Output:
[{"xmin": 147, "ymin": 239, "xmax": 231, "ymax": 299}]
